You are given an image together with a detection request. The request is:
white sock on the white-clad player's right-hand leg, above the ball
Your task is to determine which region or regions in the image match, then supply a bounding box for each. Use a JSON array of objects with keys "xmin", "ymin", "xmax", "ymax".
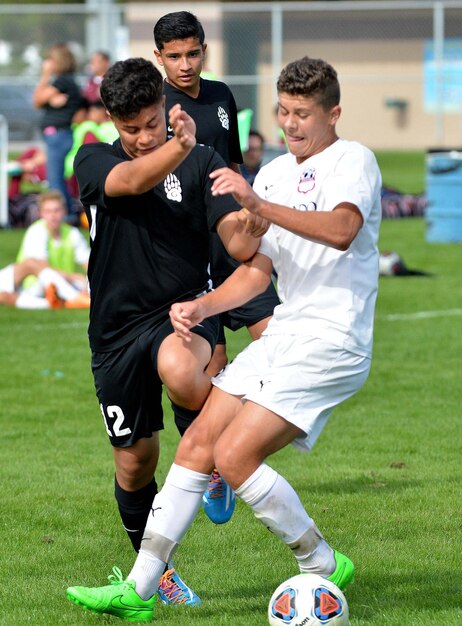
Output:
[{"xmin": 236, "ymin": 463, "xmax": 335, "ymax": 574}]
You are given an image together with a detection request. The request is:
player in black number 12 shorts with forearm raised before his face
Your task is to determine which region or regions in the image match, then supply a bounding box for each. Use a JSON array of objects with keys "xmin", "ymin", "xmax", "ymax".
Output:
[{"xmin": 74, "ymin": 59, "xmax": 266, "ymax": 604}]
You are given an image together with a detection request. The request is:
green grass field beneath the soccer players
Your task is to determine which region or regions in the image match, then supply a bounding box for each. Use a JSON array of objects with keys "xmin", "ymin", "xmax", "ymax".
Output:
[{"xmin": 0, "ymin": 154, "xmax": 462, "ymax": 626}]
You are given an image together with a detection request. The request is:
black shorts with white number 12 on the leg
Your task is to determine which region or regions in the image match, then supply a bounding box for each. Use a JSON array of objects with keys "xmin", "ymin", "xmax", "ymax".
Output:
[{"xmin": 91, "ymin": 317, "xmax": 219, "ymax": 448}]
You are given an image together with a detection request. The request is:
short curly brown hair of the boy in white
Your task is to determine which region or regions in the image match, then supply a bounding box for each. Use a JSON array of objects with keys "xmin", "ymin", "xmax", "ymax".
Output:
[{"xmin": 277, "ymin": 57, "xmax": 340, "ymax": 110}]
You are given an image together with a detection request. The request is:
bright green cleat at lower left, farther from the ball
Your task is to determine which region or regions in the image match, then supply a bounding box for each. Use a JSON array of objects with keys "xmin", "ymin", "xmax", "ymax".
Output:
[{"xmin": 66, "ymin": 567, "xmax": 156, "ymax": 622}]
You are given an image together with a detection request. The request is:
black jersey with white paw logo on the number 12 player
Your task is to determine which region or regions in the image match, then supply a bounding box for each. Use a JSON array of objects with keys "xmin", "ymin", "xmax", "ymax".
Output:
[{"xmin": 74, "ymin": 140, "xmax": 239, "ymax": 352}]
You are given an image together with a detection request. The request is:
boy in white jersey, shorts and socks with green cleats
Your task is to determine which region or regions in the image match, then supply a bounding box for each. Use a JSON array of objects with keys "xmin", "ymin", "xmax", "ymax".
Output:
[{"xmin": 68, "ymin": 57, "xmax": 381, "ymax": 620}]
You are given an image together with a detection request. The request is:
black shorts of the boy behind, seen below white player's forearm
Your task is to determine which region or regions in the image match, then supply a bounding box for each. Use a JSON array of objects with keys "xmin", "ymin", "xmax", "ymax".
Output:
[{"xmin": 217, "ymin": 282, "xmax": 280, "ymax": 344}]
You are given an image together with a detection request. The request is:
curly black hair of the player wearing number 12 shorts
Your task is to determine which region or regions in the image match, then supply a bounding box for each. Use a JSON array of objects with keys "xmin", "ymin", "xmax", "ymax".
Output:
[{"xmin": 100, "ymin": 58, "xmax": 163, "ymax": 119}]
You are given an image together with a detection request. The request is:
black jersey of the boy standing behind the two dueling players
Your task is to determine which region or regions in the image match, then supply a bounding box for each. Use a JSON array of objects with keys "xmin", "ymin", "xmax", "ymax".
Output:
[{"xmin": 164, "ymin": 78, "xmax": 242, "ymax": 165}]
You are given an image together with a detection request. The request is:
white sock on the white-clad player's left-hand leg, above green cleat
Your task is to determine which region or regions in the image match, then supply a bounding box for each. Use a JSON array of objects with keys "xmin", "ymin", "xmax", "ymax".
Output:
[{"xmin": 127, "ymin": 463, "xmax": 210, "ymax": 600}]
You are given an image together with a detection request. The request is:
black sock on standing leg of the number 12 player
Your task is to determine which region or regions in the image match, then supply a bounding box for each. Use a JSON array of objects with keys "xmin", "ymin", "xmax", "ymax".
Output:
[{"xmin": 114, "ymin": 478, "xmax": 157, "ymax": 552}]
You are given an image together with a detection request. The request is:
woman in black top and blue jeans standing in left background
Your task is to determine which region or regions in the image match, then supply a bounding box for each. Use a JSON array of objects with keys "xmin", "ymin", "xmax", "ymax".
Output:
[{"xmin": 34, "ymin": 43, "xmax": 82, "ymax": 213}]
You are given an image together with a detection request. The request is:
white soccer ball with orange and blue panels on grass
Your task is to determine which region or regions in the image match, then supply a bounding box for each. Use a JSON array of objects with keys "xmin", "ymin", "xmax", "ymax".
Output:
[{"xmin": 268, "ymin": 574, "xmax": 349, "ymax": 626}]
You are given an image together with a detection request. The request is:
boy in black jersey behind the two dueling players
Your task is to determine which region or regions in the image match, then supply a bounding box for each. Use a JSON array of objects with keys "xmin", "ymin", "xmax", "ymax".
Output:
[{"xmin": 154, "ymin": 11, "xmax": 279, "ymax": 524}]
